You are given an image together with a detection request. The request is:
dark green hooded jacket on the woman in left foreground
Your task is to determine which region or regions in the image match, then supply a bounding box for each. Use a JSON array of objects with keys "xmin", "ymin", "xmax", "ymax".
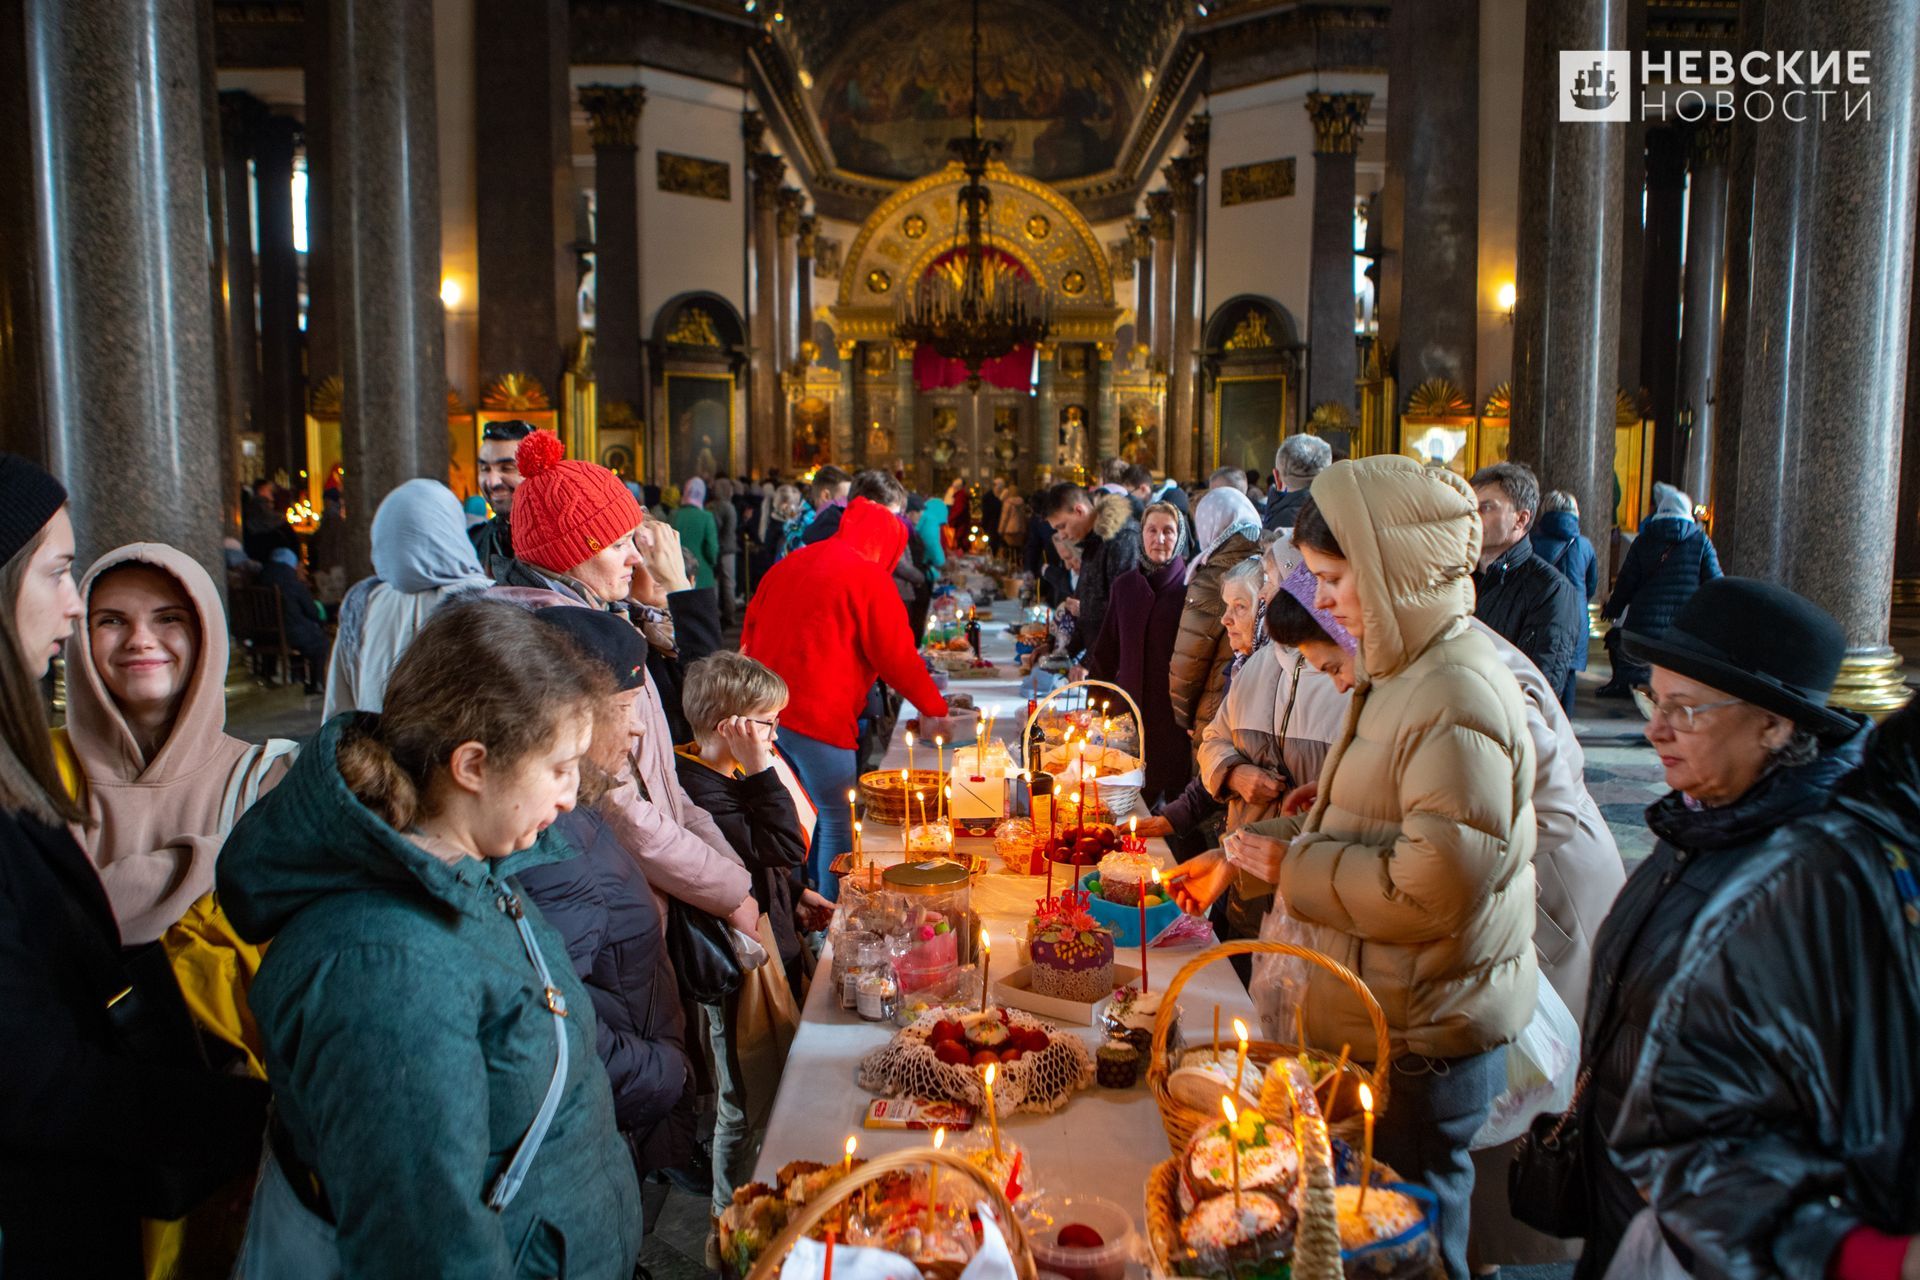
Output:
[{"xmin": 219, "ymin": 712, "xmax": 641, "ymax": 1280}]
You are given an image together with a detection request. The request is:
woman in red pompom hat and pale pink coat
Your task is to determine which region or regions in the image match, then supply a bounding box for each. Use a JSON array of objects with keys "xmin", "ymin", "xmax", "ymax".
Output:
[{"xmin": 493, "ymin": 432, "xmax": 760, "ymax": 935}]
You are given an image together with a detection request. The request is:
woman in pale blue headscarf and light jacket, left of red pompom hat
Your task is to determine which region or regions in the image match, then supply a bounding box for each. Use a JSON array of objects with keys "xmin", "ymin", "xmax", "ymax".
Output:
[{"xmin": 324, "ymin": 480, "xmax": 493, "ymax": 720}]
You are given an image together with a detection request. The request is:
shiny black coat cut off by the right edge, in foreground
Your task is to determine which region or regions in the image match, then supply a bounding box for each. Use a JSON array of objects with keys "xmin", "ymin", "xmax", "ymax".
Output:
[{"xmin": 1615, "ymin": 710, "xmax": 1920, "ymax": 1278}]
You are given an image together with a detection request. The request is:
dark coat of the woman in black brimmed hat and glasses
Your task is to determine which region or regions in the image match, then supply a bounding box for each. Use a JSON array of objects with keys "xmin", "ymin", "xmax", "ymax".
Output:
[{"xmin": 1574, "ymin": 722, "xmax": 1866, "ymax": 1280}]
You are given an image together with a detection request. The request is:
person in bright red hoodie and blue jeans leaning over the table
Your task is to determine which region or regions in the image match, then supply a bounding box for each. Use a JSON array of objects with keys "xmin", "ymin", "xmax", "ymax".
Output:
[{"xmin": 739, "ymin": 497, "xmax": 947, "ymax": 898}]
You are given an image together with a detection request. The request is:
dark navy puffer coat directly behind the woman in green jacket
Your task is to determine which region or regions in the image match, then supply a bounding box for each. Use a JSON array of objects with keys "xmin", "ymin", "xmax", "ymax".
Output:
[{"xmin": 515, "ymin": 808, "xmax": 693, "ymax": 1174}]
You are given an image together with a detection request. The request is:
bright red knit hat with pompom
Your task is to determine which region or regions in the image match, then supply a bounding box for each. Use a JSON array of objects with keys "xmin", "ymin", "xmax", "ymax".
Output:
[{"xmin": 511, "ymin": 432, "xmax": 643, "ymax": 574}]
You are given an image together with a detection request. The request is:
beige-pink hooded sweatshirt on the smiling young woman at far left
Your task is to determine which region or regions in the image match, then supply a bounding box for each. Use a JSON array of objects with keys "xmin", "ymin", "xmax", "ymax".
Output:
[{"xmin": 67, "ymin": 543, "xmax": 286, "ymax": 946}]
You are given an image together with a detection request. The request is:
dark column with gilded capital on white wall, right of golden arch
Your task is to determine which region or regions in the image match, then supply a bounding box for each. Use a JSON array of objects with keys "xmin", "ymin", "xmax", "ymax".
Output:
[{"xmin": 1306, "ymin": 94, "xmax": 1373, "ymax": 409}]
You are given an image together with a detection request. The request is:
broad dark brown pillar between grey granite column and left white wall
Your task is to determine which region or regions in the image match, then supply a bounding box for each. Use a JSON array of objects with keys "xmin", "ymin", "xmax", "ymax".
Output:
[{"xmin": 476, "ymin": 0, "xmax": 576, "ymax": 397}]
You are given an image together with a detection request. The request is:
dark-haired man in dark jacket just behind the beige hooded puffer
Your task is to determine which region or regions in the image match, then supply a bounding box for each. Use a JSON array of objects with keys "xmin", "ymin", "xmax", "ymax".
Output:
[{"xmin": 1473, "ymin": 462, "xmax": 1586, "ymax": 716}]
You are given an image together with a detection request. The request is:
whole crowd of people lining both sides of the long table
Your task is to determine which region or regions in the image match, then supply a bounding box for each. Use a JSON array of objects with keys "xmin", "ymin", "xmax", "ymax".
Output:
[{"xmin": 0, "ymin": 422, "xmax": 1920, "ymax": 1280}]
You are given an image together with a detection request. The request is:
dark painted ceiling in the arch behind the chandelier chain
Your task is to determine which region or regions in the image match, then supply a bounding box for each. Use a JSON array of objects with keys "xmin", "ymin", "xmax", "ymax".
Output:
[{"xmin": 795, "ymin": 0, "xmax": 1171, "ymax": 182}]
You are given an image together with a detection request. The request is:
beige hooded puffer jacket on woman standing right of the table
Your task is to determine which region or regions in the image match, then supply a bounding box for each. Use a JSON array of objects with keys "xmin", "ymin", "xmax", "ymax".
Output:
[{"xmin": 1254, "ymin": 457, "xmax": 1538, "ymax": 1057}]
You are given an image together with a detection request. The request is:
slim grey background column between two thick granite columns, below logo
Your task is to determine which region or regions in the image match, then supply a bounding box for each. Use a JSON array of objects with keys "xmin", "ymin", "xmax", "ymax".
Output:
[{"xmin": 1674, "ymin": 121, "xmax": 1726, "ymax": 503}]
